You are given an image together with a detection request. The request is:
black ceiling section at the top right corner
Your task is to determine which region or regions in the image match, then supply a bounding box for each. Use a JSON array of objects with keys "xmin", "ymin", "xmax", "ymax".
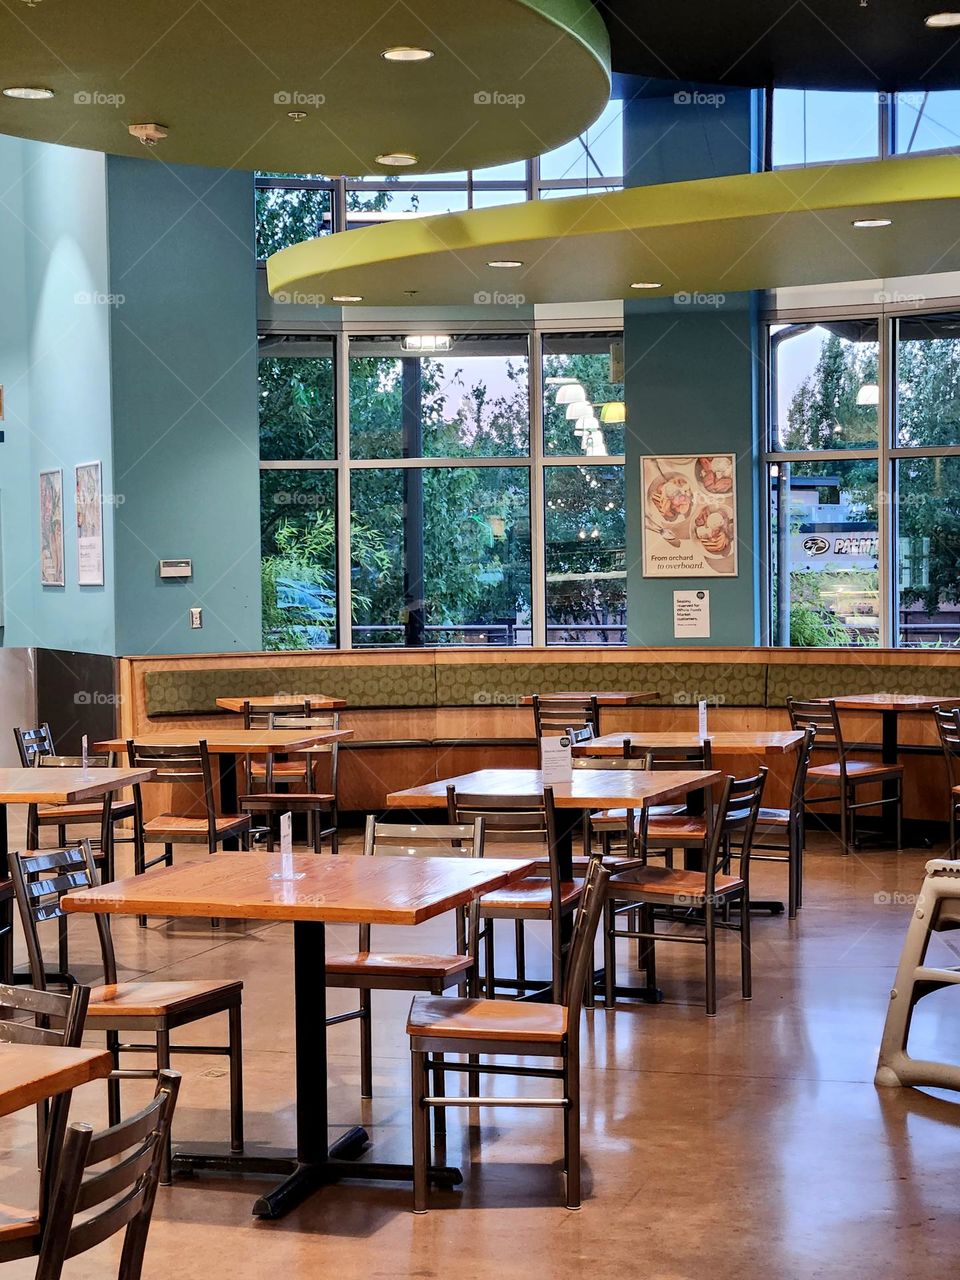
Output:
[{"xmin": 595, "ymin": 0, "xmax": 960, "ymax": 90}]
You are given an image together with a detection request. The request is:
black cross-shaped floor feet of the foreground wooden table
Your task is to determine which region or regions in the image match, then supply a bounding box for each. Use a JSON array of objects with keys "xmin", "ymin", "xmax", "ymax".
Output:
[{"xmin": 173, "ymin": 1126, "xmax": 463, "ymax": 1219}]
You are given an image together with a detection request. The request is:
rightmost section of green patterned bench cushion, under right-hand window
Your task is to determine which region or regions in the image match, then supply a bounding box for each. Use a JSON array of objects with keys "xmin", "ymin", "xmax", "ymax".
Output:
[{"xmin": 767, "ymin": 650, "xmax": 960, "ymax": 707}]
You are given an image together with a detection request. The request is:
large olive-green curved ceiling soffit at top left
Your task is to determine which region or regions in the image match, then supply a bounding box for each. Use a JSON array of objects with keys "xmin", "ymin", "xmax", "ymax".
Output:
[{"xmin": 0, "ymin": 0, "xmax": 611, "ymax": 177}]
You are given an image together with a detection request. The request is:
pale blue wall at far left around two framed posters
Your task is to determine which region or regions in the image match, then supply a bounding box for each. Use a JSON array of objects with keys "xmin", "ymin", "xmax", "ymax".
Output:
[{"xmin": 0, "ymin": 138, "xmax": 115, "ymax": 653}]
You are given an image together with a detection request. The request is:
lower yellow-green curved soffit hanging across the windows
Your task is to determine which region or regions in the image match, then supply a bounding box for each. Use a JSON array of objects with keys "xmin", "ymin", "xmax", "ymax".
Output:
[{"xmin": 268, "ymin": 156, "xmax": 960, "ymax": 306}]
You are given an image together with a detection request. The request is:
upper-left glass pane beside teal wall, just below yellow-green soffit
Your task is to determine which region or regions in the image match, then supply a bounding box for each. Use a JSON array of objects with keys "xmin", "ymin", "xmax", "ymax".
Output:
[{"xmin": 257, "ymin": 353, "xmax": 334, "ymax": 462}]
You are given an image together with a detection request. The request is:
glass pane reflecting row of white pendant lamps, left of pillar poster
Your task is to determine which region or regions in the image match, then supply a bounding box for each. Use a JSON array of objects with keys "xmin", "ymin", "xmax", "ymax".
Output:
[{"xmin": 543, "ymin": 333, "xmax": 626, "ymax": 457}]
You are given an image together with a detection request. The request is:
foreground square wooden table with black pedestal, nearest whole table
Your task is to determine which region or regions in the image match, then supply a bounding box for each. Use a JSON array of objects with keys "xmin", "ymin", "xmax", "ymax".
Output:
[{"xmin": 63, "ymin": 854, "xmax": 532, "ymax": 1217}]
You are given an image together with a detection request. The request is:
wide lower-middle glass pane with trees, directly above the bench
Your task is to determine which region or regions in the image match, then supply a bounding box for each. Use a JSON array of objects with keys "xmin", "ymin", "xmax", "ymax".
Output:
[{"xmin": 351, "ymin": 467, "xmax": 531, "ymax": 646}]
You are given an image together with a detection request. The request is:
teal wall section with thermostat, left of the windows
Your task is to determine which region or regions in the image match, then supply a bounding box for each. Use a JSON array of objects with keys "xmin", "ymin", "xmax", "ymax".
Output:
[{"xmin": 106, "ymin": 156, "xmax": 261, "ymax": 654}]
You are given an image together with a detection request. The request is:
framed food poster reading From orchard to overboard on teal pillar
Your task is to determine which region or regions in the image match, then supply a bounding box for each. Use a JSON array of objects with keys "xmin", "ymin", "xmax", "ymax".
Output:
[{"xmin": 640, "ymin": 453, "xmax": 737, "ymax": 577}]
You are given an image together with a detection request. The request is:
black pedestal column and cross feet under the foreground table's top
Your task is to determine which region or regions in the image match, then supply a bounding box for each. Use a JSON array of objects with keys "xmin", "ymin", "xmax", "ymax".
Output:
[{"xmin": 173, "ymin": 920, "xmax": 463, "ymax": 1219}]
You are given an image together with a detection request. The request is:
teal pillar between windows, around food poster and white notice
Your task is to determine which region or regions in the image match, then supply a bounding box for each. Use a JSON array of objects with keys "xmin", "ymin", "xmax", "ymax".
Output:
[{"xmin": 623, "ymin": 84, "xmax": 760, "ymax": 646}]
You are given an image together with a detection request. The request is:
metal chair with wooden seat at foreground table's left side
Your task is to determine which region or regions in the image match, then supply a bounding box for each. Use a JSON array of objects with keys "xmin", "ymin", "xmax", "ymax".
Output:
[{"xmin": 10, "ymin": 841, "xmax": 243, "ymax": 1183}]
